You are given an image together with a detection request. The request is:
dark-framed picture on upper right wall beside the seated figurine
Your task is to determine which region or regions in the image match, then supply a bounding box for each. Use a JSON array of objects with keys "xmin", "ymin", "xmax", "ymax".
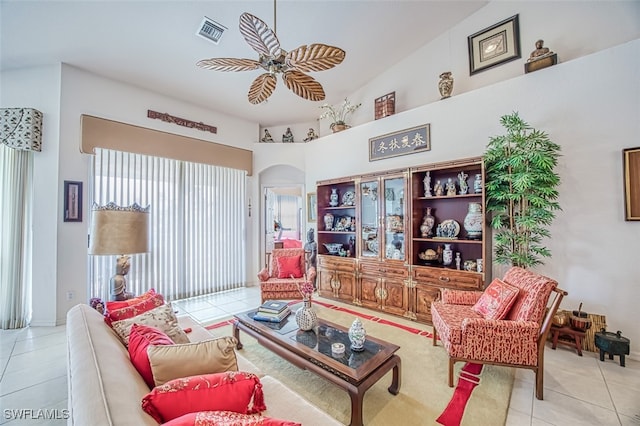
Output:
[{"xmin": 467, "ymin": 15, "xmax": 521, "ymax": 75}]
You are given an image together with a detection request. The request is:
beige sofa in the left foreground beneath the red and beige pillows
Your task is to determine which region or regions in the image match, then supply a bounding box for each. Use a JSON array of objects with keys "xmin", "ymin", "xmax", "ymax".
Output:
[{"xmin": 67, "ymin": 305, "xmax": 342, "ymax": 426}]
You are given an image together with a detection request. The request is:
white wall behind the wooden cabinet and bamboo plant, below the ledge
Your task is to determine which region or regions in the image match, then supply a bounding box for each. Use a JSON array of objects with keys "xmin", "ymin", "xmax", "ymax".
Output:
[{"xmin": 306, "ymin": 39, "xmax": 640, "ymax": 358}]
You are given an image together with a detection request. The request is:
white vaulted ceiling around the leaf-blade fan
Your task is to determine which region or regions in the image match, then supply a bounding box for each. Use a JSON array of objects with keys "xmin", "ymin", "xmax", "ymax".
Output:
[{"xmin": 0, "ymin": 0, "xmax": 487, "ymax": 126}]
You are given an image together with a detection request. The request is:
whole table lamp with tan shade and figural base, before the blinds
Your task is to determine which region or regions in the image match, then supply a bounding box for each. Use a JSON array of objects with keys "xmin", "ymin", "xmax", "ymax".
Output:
[{"xmin": 89, "ymin": 202, "xmax": 149, "ymax": 300}]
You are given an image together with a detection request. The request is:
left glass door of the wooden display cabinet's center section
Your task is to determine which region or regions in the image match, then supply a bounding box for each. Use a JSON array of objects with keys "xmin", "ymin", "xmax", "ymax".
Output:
[{"xmin": 360, "ymin": 180, "xmax": 380, "ymax": 258}]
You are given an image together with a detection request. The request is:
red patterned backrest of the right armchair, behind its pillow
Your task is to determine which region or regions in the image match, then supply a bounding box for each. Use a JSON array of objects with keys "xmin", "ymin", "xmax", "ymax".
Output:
[{"xmin": 503, "ymin": 266, "xmax": 558, "ymax": 323}]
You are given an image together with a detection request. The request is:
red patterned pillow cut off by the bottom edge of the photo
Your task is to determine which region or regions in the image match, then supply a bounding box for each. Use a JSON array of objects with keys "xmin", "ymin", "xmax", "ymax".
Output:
[{"xmin": 163, "ymin": 411, "xmax": 302, "ymax": 426}]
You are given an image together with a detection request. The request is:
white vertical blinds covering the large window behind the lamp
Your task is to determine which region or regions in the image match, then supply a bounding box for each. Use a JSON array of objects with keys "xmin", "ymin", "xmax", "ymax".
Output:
[{"xmin": 89, "ymin": 148, "xmax": 246, "ymax": 300}]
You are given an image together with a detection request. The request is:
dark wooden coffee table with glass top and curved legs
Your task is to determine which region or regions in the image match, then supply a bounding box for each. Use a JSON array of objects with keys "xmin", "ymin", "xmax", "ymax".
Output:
[{"xmin": 233, "ymin": 310, "xmax": 400, "ymax": 426}]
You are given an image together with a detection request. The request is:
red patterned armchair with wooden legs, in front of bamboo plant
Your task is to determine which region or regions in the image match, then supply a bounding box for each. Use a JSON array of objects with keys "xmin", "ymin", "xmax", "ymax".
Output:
[{"xmin": 431, "ymin": 267, "xmax": 567, "ymax": 399}]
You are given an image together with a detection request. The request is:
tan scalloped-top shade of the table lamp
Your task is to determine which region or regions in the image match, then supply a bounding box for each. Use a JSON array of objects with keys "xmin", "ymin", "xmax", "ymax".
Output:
[{"xmin": 89, "ymin": 203, "xmax": 149, "ymax": 255}]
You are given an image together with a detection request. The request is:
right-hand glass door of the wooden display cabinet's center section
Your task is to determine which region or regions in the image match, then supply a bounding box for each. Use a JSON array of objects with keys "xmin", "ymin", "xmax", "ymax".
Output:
[{"xmin": 381, "ymin": 176, "xmax": 406, "ymax": 260}]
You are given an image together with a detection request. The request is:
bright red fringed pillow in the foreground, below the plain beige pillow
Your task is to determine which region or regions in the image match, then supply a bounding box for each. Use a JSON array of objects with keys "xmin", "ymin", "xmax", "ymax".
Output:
[{"xmin": 142, "ymin": 371, "xmax": 267, "ymax": 423}]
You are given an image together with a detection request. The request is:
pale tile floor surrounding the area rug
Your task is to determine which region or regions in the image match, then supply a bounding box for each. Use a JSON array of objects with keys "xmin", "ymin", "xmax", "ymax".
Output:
[{"xmin": 0, "ymin": 287, "xmax": 640, "ymax": 426}]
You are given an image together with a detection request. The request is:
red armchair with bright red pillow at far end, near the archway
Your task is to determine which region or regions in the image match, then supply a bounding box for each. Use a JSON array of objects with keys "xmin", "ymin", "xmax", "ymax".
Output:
[{"xmin": 258, "ymin": 248, "xmax": 316, "ymax": 302}]
